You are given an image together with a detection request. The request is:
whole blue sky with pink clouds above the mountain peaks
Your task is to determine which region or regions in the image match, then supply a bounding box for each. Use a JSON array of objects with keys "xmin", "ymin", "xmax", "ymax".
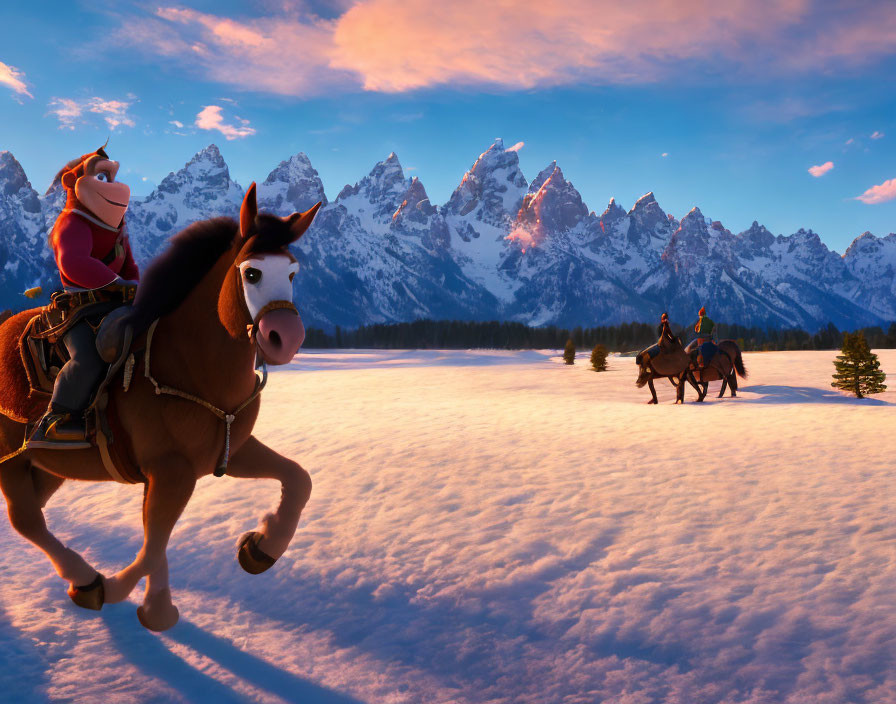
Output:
[{"xmin": 0, "ymin": 0, "xmax": 896, "ymax": 253}]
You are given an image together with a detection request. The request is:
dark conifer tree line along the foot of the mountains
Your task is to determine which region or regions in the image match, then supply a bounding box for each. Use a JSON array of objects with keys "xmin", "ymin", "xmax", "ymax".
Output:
[{"xmin": 304, "ymin": 320, "xmax": 896, "ymax": 352}]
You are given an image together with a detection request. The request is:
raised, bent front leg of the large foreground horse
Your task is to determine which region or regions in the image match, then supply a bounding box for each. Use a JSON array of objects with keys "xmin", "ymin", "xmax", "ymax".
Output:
[{"xmin": 227, "ymin": 436, "xmax": 311, "ymax": 574}]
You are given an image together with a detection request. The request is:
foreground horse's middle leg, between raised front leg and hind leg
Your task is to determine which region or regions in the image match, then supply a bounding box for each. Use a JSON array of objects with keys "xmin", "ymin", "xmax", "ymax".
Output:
[{"xmin": 104, "ymin": 455, "xmax": 196, "ymax": 604}]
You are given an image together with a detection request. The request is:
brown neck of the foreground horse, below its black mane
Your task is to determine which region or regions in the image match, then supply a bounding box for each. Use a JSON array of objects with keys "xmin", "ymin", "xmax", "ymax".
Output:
[{"xmin": 151, "ymin": 260, "xmax": 255, "ymax": 409}]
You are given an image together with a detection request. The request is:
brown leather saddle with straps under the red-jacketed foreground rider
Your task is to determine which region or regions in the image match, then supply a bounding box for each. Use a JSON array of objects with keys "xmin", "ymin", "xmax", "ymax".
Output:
[{"xmin": 19, "ymin": 286, "xmax": 145, "ymax": 484}]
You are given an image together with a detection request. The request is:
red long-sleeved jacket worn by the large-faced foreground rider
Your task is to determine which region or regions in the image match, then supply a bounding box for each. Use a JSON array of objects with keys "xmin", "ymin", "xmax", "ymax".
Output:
[{"xmin": 50, "ymin": 209, "xmax": 140, "ymax": 289}]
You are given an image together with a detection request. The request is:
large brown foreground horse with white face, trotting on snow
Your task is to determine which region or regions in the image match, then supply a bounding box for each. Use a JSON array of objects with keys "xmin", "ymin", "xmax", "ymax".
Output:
[{"xmin": 0, "ymin": 183, "xmax": 320, "ymax": 630}]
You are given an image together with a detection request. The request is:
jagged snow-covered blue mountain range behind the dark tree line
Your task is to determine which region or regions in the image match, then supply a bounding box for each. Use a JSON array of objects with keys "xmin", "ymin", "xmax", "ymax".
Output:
[{"xmin": 0, "ymin": 140, "xmax": 896, "ymax": 330}]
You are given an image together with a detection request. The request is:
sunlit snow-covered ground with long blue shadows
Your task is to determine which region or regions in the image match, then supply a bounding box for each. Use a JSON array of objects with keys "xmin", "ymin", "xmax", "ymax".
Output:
[{"xmin": 0, "ymin": 351, "xmax": 896, "ymax": 704}]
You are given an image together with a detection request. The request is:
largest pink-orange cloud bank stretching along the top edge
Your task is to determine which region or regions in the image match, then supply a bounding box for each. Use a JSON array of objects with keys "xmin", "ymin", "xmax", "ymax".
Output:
[{"xmin": 119, "ymin": 0, "xmax": 896, "ymax": 96}]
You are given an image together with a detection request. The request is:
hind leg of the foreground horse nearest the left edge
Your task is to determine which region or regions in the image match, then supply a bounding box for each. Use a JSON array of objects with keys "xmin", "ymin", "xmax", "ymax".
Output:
[{"xmin": 0, "ymin": 455, "xmax": 102, "ymax": 608}]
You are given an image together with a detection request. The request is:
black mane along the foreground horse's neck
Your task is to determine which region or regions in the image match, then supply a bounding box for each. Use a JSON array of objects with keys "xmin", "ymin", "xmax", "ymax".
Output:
[{"xmin": 132, "ymin": 217, "xmax": 239, "ymax": 334}]
